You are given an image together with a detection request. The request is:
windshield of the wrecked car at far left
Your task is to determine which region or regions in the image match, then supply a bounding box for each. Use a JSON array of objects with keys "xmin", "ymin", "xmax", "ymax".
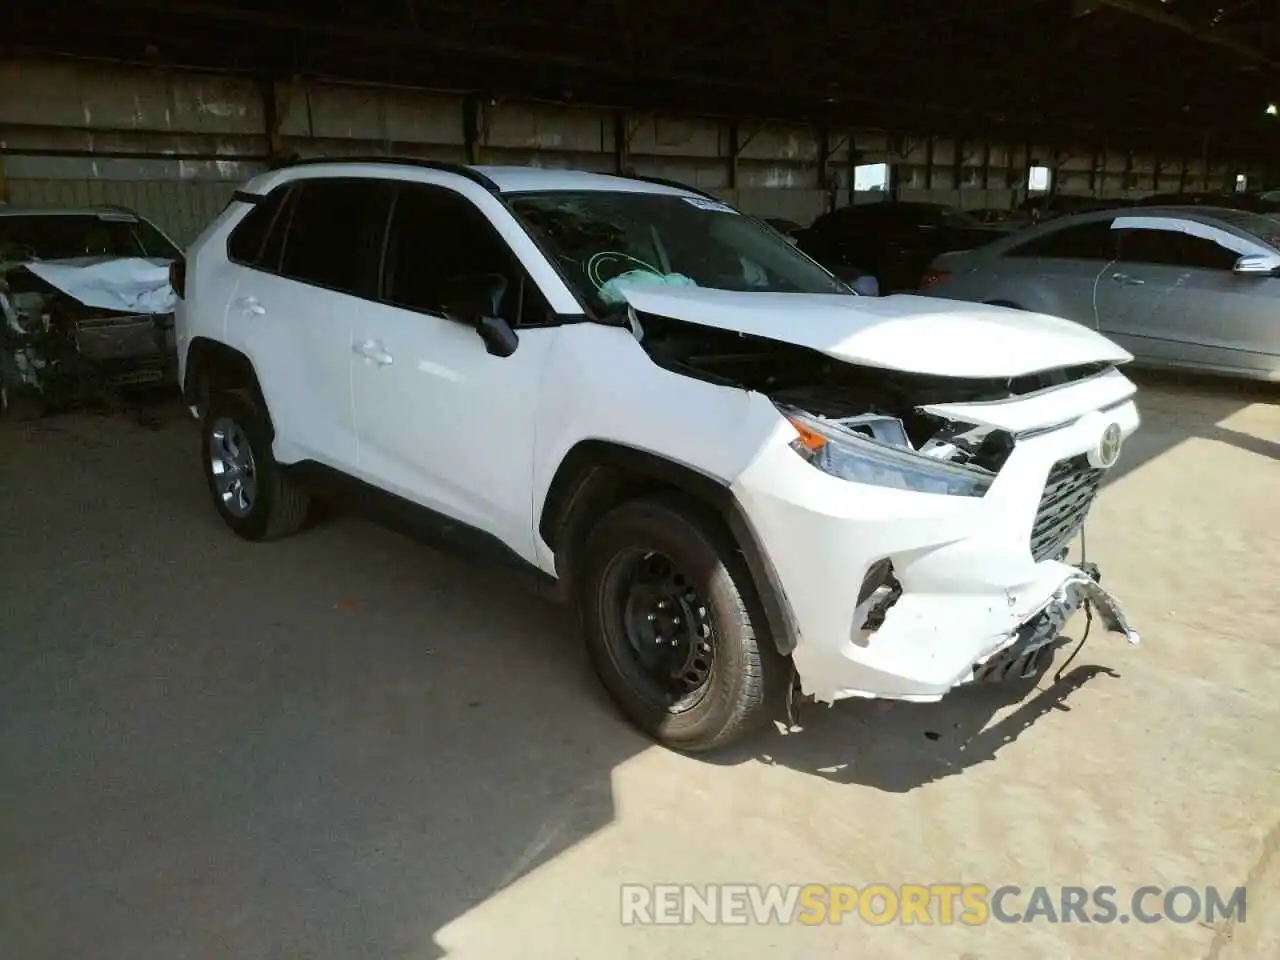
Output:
[{"xmin": 0, "ymin": 214, "xmax": 180, "ymax": 261}]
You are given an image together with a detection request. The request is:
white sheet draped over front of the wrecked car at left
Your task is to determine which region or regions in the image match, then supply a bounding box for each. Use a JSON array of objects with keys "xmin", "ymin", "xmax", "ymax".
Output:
[{"xmin": 26, "ymin": 257, "xmax": 178, "ymax": 314}]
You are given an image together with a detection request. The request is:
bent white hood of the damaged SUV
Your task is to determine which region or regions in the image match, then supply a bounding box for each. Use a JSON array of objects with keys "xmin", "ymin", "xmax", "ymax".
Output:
[{"xmin": 620, "ymin": 284, "xmax": 1133, "ymax": 378}]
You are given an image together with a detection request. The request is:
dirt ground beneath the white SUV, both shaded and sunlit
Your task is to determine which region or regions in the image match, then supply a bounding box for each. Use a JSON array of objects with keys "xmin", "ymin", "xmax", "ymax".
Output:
[{"xmin": 0, "ymin": 380, "xmax": 1280, "ymax": 960}]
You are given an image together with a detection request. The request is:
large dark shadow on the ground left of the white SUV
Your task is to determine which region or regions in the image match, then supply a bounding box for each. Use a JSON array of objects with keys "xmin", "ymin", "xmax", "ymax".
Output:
[{"xmin": 0, "ymin": 411, "xmax": 649, "ymax": 960}]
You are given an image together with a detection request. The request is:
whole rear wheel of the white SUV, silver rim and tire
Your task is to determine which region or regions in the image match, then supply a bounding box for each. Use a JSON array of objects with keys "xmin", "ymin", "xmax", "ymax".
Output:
[{"xmin": 201, "ymin": 390, "xmax": 310, "ymax": 540}]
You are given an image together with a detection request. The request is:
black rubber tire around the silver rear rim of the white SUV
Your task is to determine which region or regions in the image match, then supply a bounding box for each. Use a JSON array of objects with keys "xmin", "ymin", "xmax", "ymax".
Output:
[{"xmin": 200, "ymin": 390, "xmax": 311, "ymax": 540}]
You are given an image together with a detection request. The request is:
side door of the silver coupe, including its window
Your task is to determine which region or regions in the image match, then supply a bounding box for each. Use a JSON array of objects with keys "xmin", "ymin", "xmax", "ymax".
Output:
[{"xmin": 1100, "ymin": 220, "xmax": 1280, "ymax": 371}]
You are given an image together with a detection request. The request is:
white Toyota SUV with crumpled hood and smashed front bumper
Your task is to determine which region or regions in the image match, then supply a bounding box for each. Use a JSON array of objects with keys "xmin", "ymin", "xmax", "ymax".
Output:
[{"xmin": 175, "ymin": 160, "xmax": 1138, "ymax": 750}]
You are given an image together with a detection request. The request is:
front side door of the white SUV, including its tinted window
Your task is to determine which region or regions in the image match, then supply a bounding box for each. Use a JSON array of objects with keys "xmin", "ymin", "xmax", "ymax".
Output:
[{"xmin": 348, "ymin": 183, "xmax": 557, "ymax": 561}]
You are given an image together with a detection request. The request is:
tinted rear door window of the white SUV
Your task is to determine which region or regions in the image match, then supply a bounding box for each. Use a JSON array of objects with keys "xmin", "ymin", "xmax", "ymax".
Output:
[{"xmin": 280, "ymin": 179, "xmax": 390, "ymax": 298}]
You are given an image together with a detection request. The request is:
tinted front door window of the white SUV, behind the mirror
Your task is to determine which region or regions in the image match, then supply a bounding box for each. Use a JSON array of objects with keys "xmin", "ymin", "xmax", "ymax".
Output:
[{"xmin": 383, "ymin": 186, "xmax": 548, "ymax": 326}]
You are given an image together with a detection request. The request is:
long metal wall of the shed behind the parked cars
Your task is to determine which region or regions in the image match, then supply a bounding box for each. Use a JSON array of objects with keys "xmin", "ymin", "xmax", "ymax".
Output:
[{"xmin": 0, "ymin": 61, "xmax": 1249, "ymax": 243}]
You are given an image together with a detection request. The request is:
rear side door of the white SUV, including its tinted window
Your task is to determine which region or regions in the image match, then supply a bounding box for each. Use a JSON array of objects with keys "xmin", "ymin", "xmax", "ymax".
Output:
[{"xmin": 227, "ymin": 178, "xmax": 392, "ymax": 472}]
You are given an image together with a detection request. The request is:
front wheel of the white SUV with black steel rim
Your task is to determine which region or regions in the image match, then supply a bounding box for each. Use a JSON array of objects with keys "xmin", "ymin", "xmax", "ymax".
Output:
[{"xmin": 579, "ymin": 498, "xmax": 790, "ymax": 751}]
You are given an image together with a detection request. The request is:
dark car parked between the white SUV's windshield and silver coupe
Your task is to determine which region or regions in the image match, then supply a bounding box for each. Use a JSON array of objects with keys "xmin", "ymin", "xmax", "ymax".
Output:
[{"xmin": 796, "ymin": 201, "xmax": 1006, "ymax": 293}]
